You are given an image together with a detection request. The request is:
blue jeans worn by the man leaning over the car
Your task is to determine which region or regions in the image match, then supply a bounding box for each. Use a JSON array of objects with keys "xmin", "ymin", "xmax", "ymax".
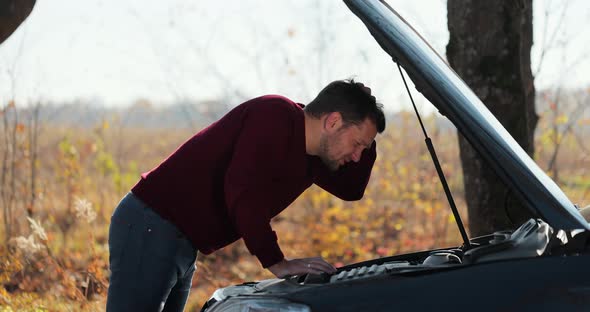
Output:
[{"xmin": 107, "ymin": 193, "xmax": 197, "ymax": 312}]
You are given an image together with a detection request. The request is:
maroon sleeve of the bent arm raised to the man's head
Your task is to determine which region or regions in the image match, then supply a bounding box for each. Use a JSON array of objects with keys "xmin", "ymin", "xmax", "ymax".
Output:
[{"xmin": 314, "ymin": 141, "xmax": 377, "ymax": 201}]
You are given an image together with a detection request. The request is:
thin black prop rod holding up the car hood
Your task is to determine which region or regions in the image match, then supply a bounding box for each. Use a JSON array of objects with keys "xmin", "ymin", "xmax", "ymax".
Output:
[{"xmin": 394, "ymin": 59, "xmax": 471, "ymax": 250}]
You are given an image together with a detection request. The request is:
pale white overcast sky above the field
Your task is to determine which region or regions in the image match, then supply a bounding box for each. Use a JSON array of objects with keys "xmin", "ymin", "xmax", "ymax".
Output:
[{"xmin": 0, "ymin": 0, "xmax": 590, "ymax": 109}]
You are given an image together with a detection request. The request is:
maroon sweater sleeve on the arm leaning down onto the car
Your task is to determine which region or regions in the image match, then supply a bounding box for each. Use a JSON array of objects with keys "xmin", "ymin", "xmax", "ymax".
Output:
[{"xmin": 224, "ymin": 103, "xmax": 292, "ymax": 268}]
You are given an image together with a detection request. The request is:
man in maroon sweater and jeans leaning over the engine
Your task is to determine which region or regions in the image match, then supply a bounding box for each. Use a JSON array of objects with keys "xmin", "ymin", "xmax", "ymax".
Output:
[{"xmin": 107, "ymin": 80, "xmax": 385, "ymax": 311}]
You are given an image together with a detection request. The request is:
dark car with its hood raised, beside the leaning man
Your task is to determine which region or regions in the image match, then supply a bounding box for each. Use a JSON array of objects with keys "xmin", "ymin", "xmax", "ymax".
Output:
[{"xmin": 203, "ymin": 0, "xmax": 590, "ymax": 312}]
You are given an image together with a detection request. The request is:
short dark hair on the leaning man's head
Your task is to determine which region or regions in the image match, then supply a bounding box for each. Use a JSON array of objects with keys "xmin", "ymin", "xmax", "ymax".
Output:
[{"xmin": 304, "ymin": 79, "xmax": 385, "ymax": 133}]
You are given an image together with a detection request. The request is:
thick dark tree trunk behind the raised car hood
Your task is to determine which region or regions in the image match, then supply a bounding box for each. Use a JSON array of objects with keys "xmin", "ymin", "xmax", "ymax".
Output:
[{"xmin": 447, "ymin": 0, "xmax": 538, "ymax": 235}]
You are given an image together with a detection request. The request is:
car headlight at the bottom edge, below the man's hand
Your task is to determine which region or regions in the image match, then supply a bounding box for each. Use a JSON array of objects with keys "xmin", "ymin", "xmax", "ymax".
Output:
[{"xmin": 207, "ymin": 297, "xmax": 311, "ymax": 312}]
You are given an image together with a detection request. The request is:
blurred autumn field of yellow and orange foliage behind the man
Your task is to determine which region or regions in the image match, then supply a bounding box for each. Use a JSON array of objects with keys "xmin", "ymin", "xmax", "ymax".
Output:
[{"xmin": 0, "ymin": 102, "xmax": 590, "ymax": 311}]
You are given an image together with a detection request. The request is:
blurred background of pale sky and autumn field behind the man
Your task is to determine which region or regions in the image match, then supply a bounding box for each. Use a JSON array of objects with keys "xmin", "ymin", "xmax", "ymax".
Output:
[{"xmin": 0, "ymin": 0, "xmax": 590, "ymax": 311}]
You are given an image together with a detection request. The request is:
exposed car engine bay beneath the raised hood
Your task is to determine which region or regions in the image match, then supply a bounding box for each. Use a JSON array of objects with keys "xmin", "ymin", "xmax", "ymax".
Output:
[{"xmin": 286, "ymin": 219, "xmax": 588, "ymax": 285}]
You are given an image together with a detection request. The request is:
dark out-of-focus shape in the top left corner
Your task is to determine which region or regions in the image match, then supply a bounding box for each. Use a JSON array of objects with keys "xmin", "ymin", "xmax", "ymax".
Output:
[{"xmin": 0, "ymin": 0, "xmax": 36, "ymax": 43}]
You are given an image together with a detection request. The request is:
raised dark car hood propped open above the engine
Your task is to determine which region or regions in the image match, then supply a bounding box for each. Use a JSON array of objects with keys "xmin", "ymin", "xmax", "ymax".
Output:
[{"xmin": 344, "ymin": 0, "xmax": 590, "ymax": 230}]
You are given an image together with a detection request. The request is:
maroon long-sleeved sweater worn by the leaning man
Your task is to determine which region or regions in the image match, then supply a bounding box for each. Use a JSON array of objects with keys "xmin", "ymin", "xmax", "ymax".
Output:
[{"xmin": 132, "ymin": 95, "xmax": 376, "ymax": 268}]
